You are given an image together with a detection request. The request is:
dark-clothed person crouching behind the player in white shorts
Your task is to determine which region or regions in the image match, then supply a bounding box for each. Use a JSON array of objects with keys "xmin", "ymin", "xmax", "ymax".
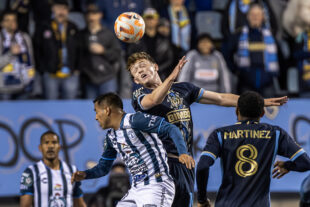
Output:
[{"xmin": 89, "ymin": 162, "xmax": 130, "ymax": 207}]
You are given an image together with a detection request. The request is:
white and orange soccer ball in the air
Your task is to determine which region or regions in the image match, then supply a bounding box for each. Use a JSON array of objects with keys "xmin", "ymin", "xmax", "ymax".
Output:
[{"xmin": 114, "ymin": 12, "xmax": 145, "ymax": 43}]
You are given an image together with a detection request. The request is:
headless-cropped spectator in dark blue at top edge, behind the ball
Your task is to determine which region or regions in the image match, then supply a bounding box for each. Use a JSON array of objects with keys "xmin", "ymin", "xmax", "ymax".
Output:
[{"xmin": 97, "ymin": 0, "xmax": 145, "ymax": 30}]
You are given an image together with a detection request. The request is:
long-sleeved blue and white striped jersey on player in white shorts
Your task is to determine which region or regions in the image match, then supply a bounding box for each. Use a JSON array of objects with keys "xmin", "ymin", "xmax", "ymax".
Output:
[{"xmin": 85, "ymin": 112, "xmax": 187, "ymax": 186}]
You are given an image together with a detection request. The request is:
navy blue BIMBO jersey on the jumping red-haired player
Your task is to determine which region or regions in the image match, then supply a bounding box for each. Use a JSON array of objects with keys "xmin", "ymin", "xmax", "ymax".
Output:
[{"xmin": 132, "ymin": 82, "xmax": 203, "ymax": 155}]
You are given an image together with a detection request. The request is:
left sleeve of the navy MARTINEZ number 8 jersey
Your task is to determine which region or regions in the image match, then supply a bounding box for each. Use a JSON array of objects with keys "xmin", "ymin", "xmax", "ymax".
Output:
[{"xmin": 201, "ymin": 131, "xmax": 222, "ymax": 161}]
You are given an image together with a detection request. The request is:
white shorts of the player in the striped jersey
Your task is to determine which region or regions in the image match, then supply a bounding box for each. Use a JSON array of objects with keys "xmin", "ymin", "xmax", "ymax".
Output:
[{"xmin": 116, "ymin": 179, "xmax": 175, "ymax": 207}]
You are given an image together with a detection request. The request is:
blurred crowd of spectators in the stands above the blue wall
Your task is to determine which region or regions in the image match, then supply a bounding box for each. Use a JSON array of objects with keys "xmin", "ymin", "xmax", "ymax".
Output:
[{"xmin": 0, "ymin": 0, "xmax": 310, "ymax": 100}]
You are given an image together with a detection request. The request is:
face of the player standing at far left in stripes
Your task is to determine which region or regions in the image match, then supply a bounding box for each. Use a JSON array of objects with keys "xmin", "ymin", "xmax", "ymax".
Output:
[{"xmin": 39, "ymin": 134, "xmax": 60, "ymax": 160}]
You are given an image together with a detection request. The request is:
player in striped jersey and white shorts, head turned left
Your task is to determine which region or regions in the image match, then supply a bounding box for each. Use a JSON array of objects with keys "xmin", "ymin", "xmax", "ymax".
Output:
[{"xmin": 72, "ymin": 93, "xmax": 195, "ymax": 207}]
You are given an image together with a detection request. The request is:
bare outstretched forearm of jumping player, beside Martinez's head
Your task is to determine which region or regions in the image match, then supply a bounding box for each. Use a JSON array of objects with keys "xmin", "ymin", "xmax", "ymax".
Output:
[{"xmin": 199, "ymin": 91, "xmax": 239, "ymax": 107}]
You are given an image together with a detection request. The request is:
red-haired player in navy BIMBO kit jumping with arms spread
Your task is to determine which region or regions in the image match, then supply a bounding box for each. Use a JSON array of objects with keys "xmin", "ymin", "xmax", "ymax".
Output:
[{"xmin": 127, "ymin": 52, "xmax": 287, "ymax": 207}]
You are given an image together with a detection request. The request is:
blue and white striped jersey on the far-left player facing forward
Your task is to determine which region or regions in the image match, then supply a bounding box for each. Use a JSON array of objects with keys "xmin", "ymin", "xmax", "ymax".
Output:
[{"xmin": 20, "ymin": 161, "xmax": 83, "ymax": 207}]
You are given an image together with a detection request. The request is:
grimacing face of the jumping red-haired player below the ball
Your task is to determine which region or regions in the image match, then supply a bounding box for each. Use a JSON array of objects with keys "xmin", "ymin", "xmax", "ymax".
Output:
[{"xmin": 130, "ymin": 59, "xmax": 158, "ymax": 85}]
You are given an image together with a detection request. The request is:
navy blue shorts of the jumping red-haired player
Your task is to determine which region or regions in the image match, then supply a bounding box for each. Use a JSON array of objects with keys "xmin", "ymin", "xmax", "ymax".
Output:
[{"xmin": 168, "ymin": 157, "xmax": 195, "ymax": 207}]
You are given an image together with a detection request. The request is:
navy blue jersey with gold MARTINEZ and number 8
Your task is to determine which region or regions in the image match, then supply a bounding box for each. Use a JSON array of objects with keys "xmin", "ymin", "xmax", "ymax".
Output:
[{"xmin": 202, "ymin": 121, "xmax": 305, "ymax": 207}]
